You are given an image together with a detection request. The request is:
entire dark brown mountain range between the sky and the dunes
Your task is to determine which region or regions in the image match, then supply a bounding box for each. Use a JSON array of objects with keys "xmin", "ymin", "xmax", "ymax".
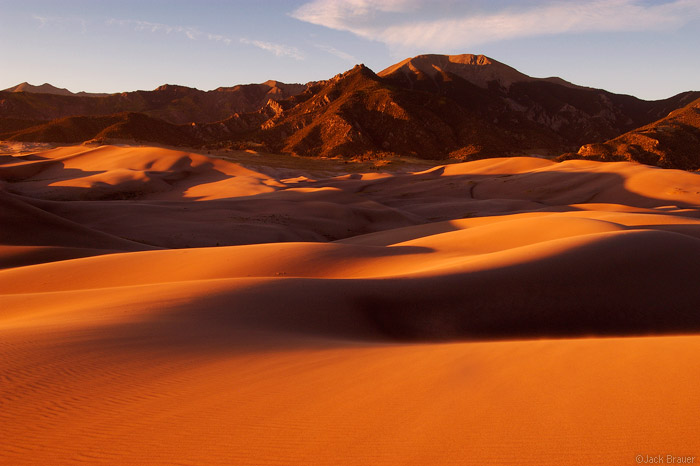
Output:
[{"xmin": 0, "ymin": 54, "xmax": 700, "ymax": 170}]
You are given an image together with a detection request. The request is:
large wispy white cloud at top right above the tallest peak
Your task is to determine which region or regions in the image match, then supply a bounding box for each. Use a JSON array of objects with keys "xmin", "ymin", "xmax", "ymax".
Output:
[{"xmin": 291, "ymin": 0, "xmax": 700, "ymax": 50}]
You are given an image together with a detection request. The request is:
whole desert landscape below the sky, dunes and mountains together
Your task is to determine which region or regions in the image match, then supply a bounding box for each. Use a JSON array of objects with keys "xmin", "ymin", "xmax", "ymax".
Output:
[{"xmin": 0, "ymin": 55, "xmax": 700, "ymax": 465}]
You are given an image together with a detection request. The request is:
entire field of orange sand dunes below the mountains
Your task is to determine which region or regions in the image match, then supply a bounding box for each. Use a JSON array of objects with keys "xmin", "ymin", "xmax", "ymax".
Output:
[{"xmin": 0, "ymin": 146, "xmax": 700, "ymax": 464}]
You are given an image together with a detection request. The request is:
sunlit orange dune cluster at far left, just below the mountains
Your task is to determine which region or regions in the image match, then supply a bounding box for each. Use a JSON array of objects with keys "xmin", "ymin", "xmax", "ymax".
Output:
[{"xmin": 0, "ymin": 146, "xmax": 281, "ymax": 200}]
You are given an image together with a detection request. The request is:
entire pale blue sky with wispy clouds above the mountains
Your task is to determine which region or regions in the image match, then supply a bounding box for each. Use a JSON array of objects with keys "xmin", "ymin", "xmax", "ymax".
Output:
[{"xmin": 0, "ymin": 0, "xmax": 700, "ymax": 99}]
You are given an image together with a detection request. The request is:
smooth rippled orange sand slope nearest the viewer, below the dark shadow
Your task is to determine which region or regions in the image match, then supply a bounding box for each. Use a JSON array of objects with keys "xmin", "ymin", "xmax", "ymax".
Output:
[{"xmin": 0, "ymin": 326, "xmax": 700, "ymax": 465}]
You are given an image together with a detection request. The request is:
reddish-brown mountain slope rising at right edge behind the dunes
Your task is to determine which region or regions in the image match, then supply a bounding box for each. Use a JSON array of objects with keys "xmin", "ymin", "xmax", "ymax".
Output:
[{"xmin": 561, "ymin": 99, "xmax": 700, "ymax": 170}]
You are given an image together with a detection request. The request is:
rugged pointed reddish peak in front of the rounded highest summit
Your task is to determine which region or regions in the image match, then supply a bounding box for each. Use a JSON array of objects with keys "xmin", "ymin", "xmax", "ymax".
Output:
[{"xmin": 243, "ymin": 65, "xmax": 549, "ymax": 159}]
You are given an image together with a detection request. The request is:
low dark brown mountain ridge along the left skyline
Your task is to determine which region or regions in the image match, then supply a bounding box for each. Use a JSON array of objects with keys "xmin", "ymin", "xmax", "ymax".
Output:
[{"xmin": 0, "ymin": 81, "xmax": 306, "ymax": 124}]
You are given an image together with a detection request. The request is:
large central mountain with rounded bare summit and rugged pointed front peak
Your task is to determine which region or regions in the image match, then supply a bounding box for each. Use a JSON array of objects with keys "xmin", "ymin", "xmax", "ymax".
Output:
[{"xmin": 211, "ymin": 55, "xmax": 700, "ymax": 160}]
